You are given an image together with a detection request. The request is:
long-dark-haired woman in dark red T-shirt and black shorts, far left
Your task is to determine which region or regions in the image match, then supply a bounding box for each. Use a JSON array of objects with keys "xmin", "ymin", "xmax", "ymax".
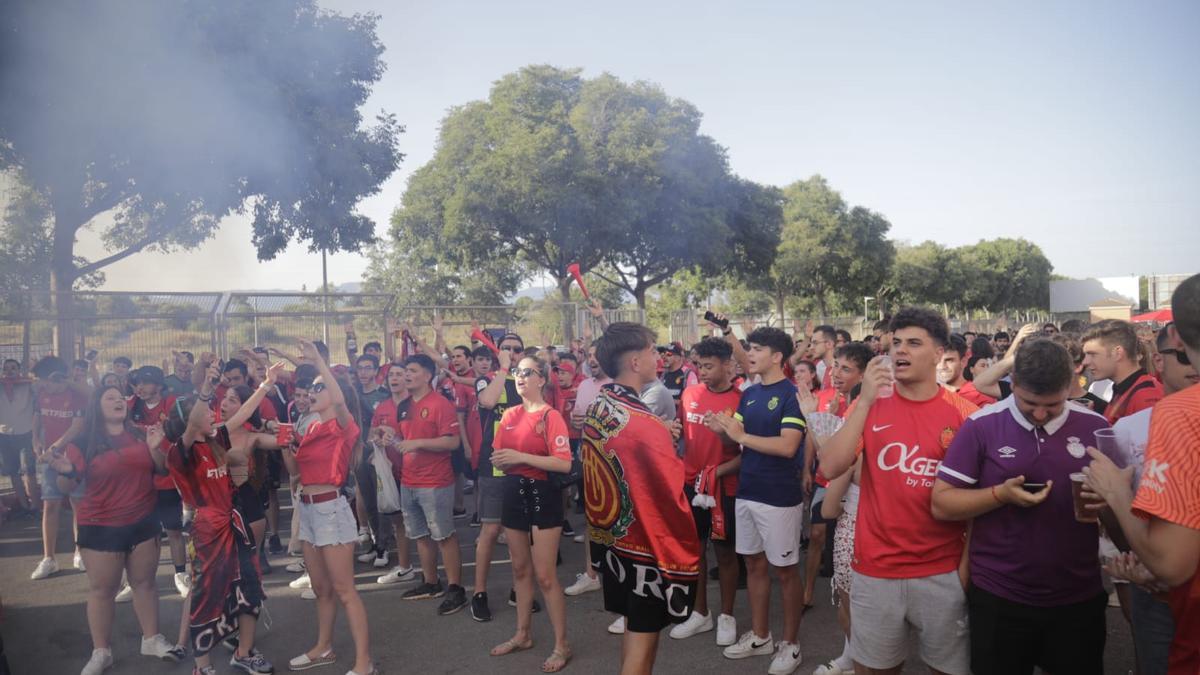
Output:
[{"xmin": 49, "ymin": 387, "xmax": 184, "ymax": 675}]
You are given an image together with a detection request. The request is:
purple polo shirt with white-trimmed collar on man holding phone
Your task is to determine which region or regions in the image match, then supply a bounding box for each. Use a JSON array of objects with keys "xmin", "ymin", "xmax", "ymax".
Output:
[{"xmin": 937, "ymin": 396, "xmax": 1116, "ymax": 607}]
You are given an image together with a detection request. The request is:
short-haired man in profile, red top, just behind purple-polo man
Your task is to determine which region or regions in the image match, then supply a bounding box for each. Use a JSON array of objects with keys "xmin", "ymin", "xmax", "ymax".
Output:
[{"xmin": 1080, "ymin": 318, "xmax": 1163, "ymax": 424}]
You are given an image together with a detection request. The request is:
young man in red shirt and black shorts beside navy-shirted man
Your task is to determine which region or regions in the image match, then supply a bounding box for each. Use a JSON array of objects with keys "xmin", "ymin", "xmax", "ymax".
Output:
[{"xmin": 670, "ymin": 338, "xmax": 742, "ymax": 646}]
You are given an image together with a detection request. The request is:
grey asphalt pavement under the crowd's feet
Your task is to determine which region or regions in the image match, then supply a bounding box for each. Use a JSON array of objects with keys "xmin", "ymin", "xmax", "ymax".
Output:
[{"xmin": 0, "ymin": 491, "xmax": 1133, "ymax": 675}]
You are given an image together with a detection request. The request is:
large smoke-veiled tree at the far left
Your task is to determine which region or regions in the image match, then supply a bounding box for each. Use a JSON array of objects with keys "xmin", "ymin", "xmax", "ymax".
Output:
[{"xmin": 0, "ymin": 0, "xmax": 402, "ymax": 353}]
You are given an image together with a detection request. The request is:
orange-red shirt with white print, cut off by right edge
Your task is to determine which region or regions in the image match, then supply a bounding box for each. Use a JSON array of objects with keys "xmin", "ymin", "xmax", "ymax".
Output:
[{"xmin": 1133, "ymin": 387, "xmax": 1200, "ymax": 675}]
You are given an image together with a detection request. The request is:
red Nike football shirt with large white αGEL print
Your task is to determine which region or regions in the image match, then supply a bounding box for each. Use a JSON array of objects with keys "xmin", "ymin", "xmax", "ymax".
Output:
[{"xmin": 853, "ymin": 388, "xmax": 979, "ymax": 579}]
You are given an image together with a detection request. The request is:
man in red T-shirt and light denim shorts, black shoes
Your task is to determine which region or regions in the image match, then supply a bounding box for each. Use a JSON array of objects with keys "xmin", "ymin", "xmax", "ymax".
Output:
[{"xmin": 396, "ymin": 354, "xmax": 467, "ymax": 615}]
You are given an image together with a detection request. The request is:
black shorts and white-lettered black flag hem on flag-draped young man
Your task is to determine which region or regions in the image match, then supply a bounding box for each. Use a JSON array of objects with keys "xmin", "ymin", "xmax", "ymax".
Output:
[{"xmin": 588, "ymin": 542, "xmax": 697, "ymax": 633}]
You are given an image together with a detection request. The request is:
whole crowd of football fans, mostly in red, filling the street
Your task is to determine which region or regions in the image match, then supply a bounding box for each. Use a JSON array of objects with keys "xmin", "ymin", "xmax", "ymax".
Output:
[{"xmin": 0, "ymin": 269, "xmax": 1200, "ymax": 675}]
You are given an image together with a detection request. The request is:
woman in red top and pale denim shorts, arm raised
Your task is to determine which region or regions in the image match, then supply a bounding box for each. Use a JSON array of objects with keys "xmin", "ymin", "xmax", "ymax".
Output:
[{"xmin": 283, "ymin": 340, "xmax": 376, "ymax": 675}]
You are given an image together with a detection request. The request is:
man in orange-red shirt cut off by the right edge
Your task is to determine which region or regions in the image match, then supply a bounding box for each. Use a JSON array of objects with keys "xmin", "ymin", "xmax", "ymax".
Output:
[{"xmin": 1085, "ymin": 275, "xmax": 1200, "ymax": 675}]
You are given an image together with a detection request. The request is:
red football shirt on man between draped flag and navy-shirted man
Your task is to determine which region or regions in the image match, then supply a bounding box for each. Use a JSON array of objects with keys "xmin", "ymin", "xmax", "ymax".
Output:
[{"xmin": 679, "ymin": 384, "xmax": 742, "ymax": 496}]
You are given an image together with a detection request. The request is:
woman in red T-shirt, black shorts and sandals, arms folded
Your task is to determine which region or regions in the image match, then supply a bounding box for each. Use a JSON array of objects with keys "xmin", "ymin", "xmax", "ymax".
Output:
[{"xmin": 492, "ymin": 357, "xmax": 571, "ymax": 673}]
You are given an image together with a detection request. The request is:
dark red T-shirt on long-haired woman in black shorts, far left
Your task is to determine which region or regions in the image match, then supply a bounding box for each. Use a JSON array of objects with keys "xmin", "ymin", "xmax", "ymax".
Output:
[{"xmin": 66, "ymin": 431, "xmax": 158, "ymax": 527}]
